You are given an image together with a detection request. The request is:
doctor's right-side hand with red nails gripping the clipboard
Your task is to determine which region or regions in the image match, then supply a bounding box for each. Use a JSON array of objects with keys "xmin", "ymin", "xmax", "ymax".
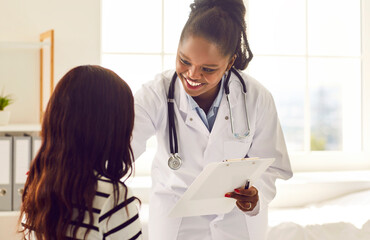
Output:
[{"xmin": 225, "ymin": 187, "xmax": 258, "ymax": 212}]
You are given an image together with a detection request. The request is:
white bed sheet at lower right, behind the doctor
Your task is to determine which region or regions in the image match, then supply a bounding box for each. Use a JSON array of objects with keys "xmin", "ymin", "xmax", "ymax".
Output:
[{"xmin": 268, "ymin": 190, "xmax": 370, "ymax": 240}]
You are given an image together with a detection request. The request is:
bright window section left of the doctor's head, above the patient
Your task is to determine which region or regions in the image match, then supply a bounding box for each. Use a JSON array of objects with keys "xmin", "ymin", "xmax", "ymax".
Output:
[{"xmin": 101, "ymin": 0, "xmax": 192, "ymax": 92}]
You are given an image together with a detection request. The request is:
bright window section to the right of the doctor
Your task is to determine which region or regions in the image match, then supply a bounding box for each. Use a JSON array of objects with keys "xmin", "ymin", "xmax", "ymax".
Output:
[{"xmin": 247, "ymin": 0, "xmax": 368, "ymax": 170}]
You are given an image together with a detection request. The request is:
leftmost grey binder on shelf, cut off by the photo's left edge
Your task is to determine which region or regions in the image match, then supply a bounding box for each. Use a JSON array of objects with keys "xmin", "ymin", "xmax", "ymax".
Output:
[{"xmin": 0, "ymin": 137, "xmax": 13, "ymax": 211}]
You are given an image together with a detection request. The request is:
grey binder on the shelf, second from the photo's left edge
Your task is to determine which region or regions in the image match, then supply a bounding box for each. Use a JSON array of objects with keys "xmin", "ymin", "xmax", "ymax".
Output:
[{"xmin": 13, "ymin": 136, "xmax": 32, "ymax": 210}]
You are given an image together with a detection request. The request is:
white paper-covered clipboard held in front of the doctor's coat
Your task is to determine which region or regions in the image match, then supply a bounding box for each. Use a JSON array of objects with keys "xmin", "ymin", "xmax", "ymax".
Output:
[{"xmin": 169, "ymin": 158, "xmax": 275, "ymax": 217}]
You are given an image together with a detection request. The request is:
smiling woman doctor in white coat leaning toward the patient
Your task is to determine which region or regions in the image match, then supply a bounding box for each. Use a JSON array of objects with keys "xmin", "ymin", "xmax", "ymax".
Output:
[{"xmin": 132, "ymin": 0, "xmax": 292, "ymax": 240}]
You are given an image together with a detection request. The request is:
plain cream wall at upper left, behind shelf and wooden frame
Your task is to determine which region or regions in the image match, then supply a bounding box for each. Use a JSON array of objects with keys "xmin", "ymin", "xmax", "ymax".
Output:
[{"xmin": 0, "ymin": 0, "xmax": 100, "ymax": 123}]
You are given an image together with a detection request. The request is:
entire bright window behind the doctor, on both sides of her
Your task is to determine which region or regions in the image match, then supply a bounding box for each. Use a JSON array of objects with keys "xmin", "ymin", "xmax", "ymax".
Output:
[{"xmin": 102, "ymin": 0, "xmax": 370, "ymax": 172}]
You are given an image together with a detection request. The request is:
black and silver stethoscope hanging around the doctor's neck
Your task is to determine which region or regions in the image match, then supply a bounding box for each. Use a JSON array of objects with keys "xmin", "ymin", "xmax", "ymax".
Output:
[{"xmin": 167, "ymin": 68, "xmax": 250, "ymax": 170}]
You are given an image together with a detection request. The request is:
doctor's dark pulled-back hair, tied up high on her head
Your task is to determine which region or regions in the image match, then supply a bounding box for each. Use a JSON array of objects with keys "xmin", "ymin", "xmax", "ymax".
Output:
[{"xmin": 180, "ymin": 0, "xmax": 253, "ymax": 70}]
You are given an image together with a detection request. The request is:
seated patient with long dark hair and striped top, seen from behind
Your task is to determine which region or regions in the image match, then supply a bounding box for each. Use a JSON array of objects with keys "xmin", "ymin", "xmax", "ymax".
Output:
[{"xmin": 20, "ymin": 66, "xmax": 142, "ymax": 240}]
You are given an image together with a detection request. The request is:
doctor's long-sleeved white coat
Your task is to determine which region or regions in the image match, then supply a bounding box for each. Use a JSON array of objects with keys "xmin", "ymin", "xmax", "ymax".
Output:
[{"xmin": 132, "ymin": 71, "xmax": 292, "ymax": 240}]
